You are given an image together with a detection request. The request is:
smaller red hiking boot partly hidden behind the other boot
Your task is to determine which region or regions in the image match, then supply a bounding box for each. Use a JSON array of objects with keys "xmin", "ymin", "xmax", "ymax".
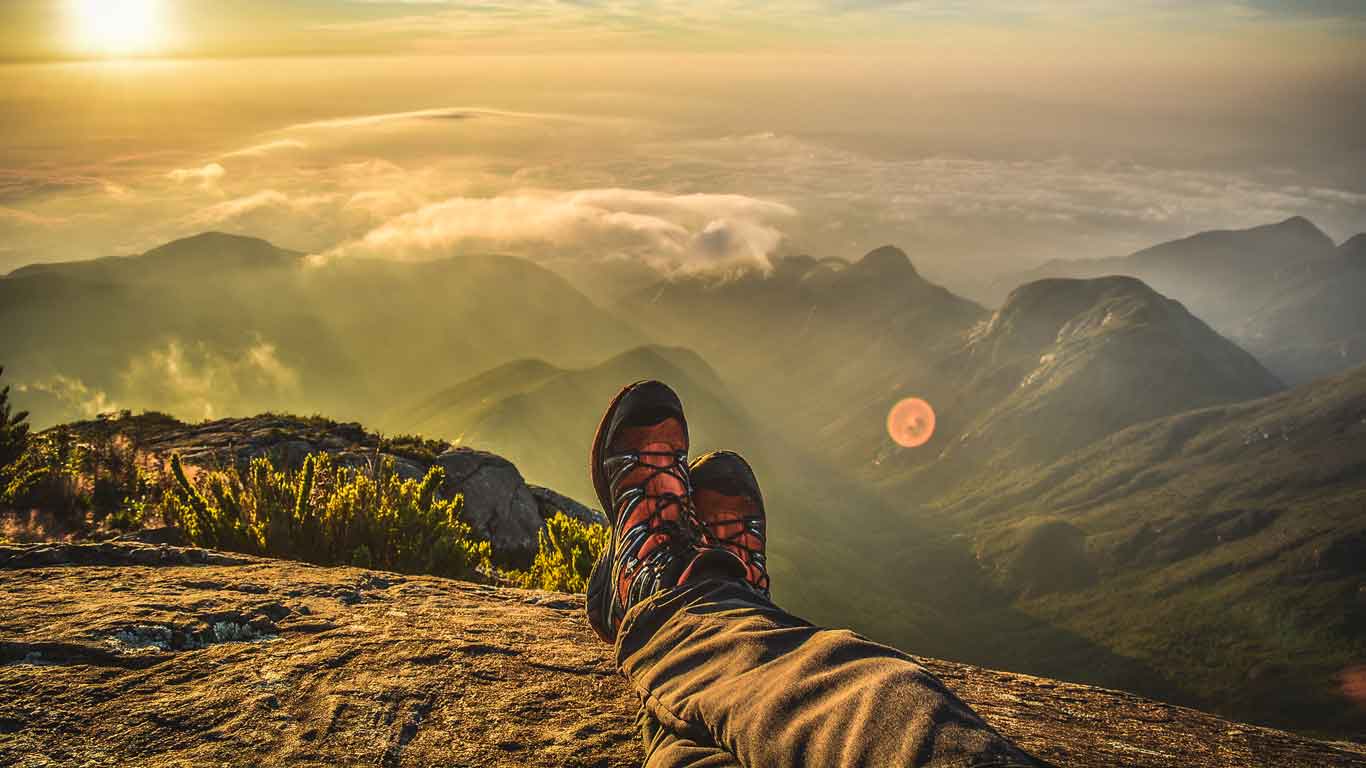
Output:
[{"xmin": 688, "ymin": 451, "xmax": 769, "ymax": 597}]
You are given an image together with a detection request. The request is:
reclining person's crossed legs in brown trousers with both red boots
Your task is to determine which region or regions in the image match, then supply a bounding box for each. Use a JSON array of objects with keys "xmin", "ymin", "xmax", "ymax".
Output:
[{"xmin": 586, "ymin": 381, "xmax": 1037, "ymax": 768}]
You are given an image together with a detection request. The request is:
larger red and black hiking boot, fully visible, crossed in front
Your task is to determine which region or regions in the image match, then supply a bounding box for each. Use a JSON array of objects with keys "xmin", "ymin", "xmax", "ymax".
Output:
[{"xmin": 587, "ymin": 381, "xmax": 699, "ymax": 642}]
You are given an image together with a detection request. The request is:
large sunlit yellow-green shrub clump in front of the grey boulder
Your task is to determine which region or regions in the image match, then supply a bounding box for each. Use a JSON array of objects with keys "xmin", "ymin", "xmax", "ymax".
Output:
[{"xmin": 171, "ymin": 454, "xmax": 492, "ymax": 578}]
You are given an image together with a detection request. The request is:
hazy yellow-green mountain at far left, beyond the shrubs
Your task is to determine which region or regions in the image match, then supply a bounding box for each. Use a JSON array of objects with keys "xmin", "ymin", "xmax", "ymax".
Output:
[{"xmin": 0, "ymin": 234, "xmax": 639, "ymax": 424}]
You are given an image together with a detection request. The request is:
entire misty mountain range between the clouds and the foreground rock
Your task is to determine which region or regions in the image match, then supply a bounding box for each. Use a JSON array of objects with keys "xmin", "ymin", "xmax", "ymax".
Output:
[{"xmin": 8, "ymin": 220, "xmax": 1366, "ymax": 735}]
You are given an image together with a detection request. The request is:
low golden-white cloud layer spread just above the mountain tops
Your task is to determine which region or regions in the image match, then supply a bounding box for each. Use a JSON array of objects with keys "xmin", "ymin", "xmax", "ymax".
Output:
[{"xmin": 0, "ymin": 72, "xmax": 1366, "ymax": 286}]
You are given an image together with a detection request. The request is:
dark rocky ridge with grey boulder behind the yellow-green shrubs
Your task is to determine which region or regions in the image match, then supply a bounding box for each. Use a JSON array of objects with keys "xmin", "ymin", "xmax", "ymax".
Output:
[{"xmin": 58, "ymin": 414, "xmax": 604, "ymax": 567}]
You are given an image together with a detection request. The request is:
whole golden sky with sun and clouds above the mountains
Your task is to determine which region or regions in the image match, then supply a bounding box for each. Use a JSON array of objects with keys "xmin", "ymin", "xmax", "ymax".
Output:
[{"xmin": 0, "ymin": 0, "xmax": 1366, "ymax": 286}]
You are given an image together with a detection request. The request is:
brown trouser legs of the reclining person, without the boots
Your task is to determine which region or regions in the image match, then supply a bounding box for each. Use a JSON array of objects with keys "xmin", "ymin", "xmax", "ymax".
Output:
[{"xmin": 616, "ymin": 579, "xmax": 1040, "ymax": 768}]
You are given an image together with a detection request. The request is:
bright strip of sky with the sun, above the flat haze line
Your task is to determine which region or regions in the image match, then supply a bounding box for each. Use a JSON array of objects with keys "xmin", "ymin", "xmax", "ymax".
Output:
[{"xmin": 0, "ymin": 0, "xmax": 1366, "ymax": 61}]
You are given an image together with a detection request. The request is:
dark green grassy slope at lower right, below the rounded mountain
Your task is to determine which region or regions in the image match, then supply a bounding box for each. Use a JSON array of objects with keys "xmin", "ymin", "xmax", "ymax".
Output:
[{"xmin": 940, "ymin": 368, "xmax": 1366, "ymax": 732}]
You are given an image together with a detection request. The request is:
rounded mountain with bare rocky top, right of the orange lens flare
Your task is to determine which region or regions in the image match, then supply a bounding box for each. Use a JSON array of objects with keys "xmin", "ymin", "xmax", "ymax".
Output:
[{"xmin": 888, "ymin": 277, "xmax": 1281, "ymax": 482}]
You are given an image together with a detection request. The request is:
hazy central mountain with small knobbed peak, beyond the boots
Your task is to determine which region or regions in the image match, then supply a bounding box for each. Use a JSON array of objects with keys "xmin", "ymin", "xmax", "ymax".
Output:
[{"xmin": 634, "ymin": 246, "xmax": 986, "ymax": 439}]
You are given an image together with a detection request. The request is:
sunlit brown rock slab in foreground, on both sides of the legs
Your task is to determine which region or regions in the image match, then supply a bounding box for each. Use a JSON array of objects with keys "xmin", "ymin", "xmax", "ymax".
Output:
[{"xmin": 0, "ymin": 544, "xmax": 1366, "ymax": 768}]
